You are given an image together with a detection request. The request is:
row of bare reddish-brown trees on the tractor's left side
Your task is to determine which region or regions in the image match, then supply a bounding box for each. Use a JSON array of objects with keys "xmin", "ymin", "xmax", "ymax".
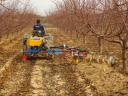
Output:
[{"xmin": 0, "ymin": 0, "xmax": 34, "ymax": 38}]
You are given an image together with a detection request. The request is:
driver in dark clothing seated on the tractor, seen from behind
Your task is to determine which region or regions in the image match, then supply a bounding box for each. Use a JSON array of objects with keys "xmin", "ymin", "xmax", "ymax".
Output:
[{"xmin": 33, "ymin": 19, "xmax": 45, "ymax": 37}]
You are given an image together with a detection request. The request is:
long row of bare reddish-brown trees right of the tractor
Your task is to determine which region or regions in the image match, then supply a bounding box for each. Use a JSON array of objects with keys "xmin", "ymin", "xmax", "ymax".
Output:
[{"xmin": 48, "ymin": 0, "xmax": 128, "ymax": 71}]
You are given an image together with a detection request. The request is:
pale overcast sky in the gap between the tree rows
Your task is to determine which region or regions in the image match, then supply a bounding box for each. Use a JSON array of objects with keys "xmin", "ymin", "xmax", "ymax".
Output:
[{"xmin": 30, "ymin": 0, "xmax": 55, "ymax": 15}]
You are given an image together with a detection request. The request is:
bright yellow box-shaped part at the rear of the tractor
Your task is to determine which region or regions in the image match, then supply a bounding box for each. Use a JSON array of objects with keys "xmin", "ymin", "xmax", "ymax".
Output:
[{"xmin": 27, "ymin": 37, "xmax": 45, "ymax": 46}]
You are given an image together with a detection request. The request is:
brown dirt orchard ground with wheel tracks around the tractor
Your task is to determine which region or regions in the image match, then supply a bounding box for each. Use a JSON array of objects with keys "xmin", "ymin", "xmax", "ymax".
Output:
[{"xmin": 0, "ymin": 28, "xmax": 128, "ymax": 96}]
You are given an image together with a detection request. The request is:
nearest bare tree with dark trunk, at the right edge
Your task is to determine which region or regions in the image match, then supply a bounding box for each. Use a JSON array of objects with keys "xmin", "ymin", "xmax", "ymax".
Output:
[{"xmin": 104, "ymin": 0, "xmax": 128, "ymax": 71}]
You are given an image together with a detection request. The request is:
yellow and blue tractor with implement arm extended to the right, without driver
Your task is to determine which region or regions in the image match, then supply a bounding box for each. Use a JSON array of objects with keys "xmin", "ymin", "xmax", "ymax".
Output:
[{"xmin": 22, "ymin": 34, "xmax": 88, "ymax": 64}]
